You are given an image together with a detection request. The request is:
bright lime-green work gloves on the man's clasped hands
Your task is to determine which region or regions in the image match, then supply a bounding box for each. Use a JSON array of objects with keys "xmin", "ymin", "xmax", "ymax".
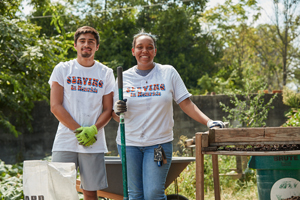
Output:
[{"xmin": 75, "ymin": 125, "xmax": 98, "ymax": 146}]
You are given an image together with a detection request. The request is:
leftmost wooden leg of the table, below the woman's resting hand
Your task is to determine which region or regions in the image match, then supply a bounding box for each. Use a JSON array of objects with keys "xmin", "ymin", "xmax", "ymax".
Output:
[{"xmin": 195, "ymin": 133, "xmax": 204, "ymax": 200}]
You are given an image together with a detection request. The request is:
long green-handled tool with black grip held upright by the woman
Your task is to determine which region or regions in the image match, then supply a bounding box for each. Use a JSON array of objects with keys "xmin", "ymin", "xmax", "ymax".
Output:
[{"xmin": 117, "ymin": 67, "xmax": 128, "ymax": 200}]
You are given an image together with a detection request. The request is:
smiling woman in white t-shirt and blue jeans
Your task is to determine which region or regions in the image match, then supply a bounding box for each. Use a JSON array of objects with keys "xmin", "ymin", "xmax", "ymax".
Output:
[{"xmin": 113, "ymin": 30, "xmax": 224, "ymax": 199}]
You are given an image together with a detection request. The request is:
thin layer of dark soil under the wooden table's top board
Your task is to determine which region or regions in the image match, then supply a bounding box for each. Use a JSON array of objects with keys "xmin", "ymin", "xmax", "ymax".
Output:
[{"xmin": 218, "ymin": 144, "xmax": 300, "ymax": 151}]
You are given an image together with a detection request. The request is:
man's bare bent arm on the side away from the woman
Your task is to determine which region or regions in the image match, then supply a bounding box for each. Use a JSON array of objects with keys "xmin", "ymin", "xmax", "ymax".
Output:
[{"xmin": 50, "ymin": 81, "xmax": 80, "ymax": 131}]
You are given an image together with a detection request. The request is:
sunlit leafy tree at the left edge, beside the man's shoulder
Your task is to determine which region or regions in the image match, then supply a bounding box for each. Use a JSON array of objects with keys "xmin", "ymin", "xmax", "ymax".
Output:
[{"xmin": 0, "ymin": 15, "xmax": 69, "ymax": 136}]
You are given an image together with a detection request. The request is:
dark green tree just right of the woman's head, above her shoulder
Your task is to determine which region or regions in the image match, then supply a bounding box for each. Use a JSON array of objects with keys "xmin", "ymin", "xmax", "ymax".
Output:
[{"xmin": 147, "ymin": 4, "xmax": 219, "ymax": 88}]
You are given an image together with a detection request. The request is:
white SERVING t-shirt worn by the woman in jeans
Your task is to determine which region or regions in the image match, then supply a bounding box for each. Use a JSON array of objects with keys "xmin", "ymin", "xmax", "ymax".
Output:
[{"xmin": 114, "ymin": 63, "xmax": 191, "ymax": 146}]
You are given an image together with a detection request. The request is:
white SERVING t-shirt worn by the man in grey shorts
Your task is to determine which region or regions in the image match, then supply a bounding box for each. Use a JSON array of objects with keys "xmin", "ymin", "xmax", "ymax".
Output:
[{"xmin": 49, "ymin": 59, "xmax": 115, "ymax": 153}]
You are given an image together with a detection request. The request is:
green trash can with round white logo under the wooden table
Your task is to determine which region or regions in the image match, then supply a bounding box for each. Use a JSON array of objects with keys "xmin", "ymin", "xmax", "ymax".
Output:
[{"xmin": 248, "ymin": 155, "xmax": 300, "ymax": 200}]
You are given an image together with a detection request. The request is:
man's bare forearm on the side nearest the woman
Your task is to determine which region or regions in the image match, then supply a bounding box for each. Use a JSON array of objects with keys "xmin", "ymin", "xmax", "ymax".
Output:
[{"xmin": 95, "ymin": 92, "xmax": 114, "ymax": 130}]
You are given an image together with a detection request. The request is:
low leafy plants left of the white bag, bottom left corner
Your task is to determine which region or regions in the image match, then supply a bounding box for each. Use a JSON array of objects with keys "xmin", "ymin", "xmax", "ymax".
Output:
[{"xmin": 0, "ymin": 160, "xmax": 24, "ymax": 200}]
